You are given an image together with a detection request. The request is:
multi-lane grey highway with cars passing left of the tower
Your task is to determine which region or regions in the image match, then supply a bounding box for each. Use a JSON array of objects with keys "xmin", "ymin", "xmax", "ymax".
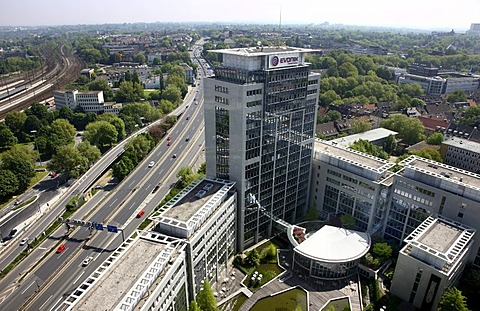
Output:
[{"xmin": 8, "ymin": 82, "xmax": 204, "ymax": 310}]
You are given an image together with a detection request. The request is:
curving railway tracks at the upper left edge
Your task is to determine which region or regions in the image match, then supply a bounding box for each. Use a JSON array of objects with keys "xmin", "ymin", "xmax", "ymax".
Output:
[{"xmin": 0, "ymin": 45, "xmax": 86, "ymax": 120}]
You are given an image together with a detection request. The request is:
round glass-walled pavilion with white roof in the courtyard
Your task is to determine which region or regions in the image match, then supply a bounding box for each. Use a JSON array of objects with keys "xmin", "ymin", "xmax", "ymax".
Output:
[{"xmin": 291, "ymin": 226, "xmax": 371, "ymax": 280}]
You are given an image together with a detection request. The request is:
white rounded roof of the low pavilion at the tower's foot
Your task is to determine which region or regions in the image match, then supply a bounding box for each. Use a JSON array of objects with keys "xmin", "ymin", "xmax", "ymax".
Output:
[{"xmin": 295, "ymin": 225, "xmax": 371, "ymax": 263}]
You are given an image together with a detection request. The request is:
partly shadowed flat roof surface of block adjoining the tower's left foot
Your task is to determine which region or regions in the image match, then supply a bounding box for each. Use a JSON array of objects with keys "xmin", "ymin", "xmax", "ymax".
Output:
[{"xmin": 162, "ymin": 179, "xmax": 225, "ymax": 222}]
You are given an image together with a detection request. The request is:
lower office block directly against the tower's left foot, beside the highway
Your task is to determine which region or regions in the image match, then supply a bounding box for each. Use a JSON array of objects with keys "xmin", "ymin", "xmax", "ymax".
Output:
[{"xmin": 151, "ymin": 179, "xmax": 237, "ymax": 297}]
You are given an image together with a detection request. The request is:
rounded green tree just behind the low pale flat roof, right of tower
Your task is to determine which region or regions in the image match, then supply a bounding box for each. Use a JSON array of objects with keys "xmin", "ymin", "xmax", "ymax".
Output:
[{"xmin": 381, "ymin": 114, "xmax": 425, "ymax": 145}]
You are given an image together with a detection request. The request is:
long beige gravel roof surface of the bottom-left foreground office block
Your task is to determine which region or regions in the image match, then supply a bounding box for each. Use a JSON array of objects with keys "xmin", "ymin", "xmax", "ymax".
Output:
[{"xmin": 75, "ymin": 239, "xmax": 166, "ymax": 310}]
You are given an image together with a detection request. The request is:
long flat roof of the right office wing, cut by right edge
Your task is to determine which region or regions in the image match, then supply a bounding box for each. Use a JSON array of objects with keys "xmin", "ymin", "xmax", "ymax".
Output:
[{"xmin": 400, "ymin": 156, "xmax": 480, "ymax": 191}]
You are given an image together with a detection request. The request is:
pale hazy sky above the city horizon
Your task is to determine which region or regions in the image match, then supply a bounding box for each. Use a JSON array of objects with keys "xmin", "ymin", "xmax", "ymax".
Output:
[{"xmin": 0, "ymin": 0, "xmax": 480, "ymax": 31}]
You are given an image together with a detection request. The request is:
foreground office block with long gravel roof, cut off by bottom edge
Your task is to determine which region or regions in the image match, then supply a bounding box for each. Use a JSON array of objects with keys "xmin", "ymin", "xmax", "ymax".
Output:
[{"xmin": 60, "ymin": 232, "xmax": 192, "ymax": 311}]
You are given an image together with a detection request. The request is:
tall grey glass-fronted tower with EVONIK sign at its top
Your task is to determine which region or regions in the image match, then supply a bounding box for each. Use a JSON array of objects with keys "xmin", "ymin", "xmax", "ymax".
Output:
[{"xmin": 204, "ymin": 47, "xmax": 320, "ymax": 251}]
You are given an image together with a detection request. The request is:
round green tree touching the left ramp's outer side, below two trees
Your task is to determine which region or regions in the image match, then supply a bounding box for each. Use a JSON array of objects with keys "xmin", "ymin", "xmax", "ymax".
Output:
[{"xmin": 49, "ymin": 145, "xmax": 89, "ymax": 178}]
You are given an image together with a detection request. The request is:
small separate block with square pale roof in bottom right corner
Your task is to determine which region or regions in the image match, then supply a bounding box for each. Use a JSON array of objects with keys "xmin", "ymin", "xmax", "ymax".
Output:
[{"xmin": 390, "ymin": 217, "xmax": 475, "ymax": 311}]
